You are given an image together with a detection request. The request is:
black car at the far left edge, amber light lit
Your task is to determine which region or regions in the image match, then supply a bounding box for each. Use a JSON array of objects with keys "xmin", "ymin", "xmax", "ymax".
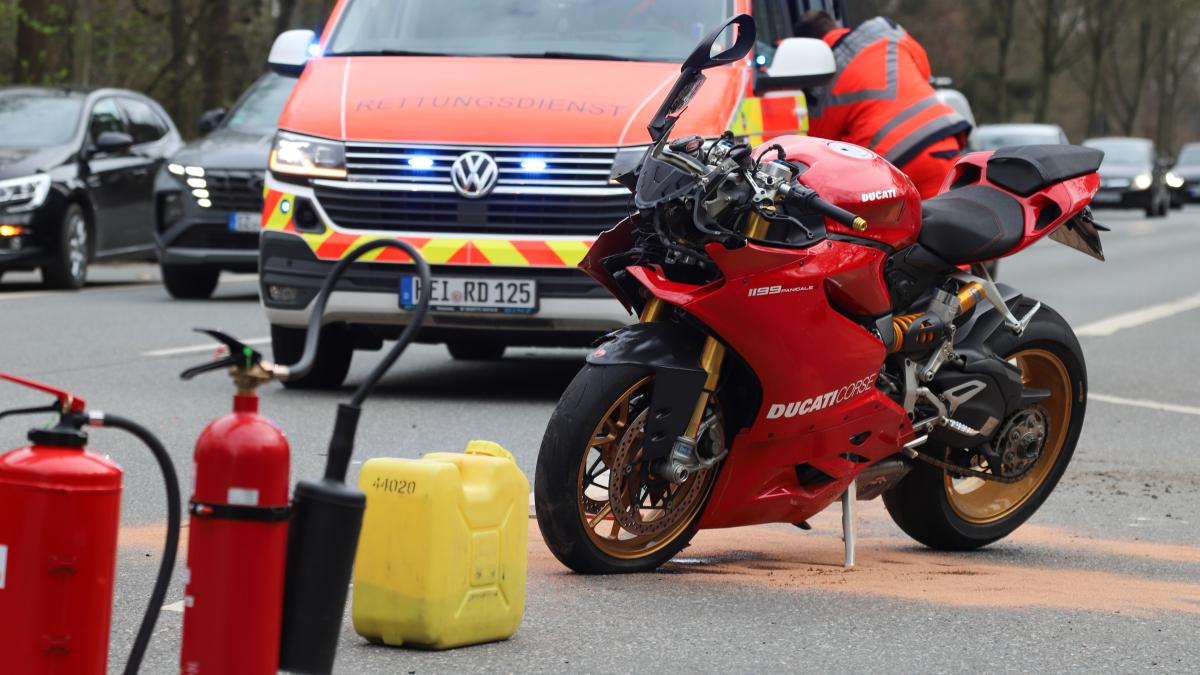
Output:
[{"xmin": 0, "ymin": 86, "xmax": 182, "ymax": 288}]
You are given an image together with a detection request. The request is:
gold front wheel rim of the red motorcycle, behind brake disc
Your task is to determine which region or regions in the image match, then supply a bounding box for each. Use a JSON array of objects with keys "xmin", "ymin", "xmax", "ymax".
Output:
[{"xmin": 576, "ymin": 377, "xmax": 719, "ymax": 560}]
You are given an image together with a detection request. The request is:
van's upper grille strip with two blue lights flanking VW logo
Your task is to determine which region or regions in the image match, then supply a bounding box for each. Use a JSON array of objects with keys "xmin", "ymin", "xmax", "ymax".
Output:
[{"xmin": 346, "ymin": 143, "xmax": 617, "ymax": 187}]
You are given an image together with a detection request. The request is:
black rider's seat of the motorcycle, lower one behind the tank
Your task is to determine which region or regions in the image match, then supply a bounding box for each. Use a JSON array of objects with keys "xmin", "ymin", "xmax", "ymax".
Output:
[{"xmin": 917, "ymin": 185, "xmax": 1025, "ymax": 265}]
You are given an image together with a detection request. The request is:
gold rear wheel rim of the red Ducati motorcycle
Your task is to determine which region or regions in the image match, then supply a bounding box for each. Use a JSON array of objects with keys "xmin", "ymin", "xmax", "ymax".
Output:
[{"xmin": 943, "ymin": 350, "xmax": 1074, "ymax": 525}]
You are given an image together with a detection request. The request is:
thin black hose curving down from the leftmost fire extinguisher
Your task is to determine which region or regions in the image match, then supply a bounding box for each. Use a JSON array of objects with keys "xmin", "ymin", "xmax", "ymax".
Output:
[{"xmin": 89, "ymin": 412, "xmax": 182, "ymax": 675}]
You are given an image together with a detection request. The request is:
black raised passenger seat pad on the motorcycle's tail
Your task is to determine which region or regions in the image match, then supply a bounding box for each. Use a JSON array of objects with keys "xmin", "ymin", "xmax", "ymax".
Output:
[{"xmin": 988, "ymin": 145, "xmax": 1104, "ymax": 197}]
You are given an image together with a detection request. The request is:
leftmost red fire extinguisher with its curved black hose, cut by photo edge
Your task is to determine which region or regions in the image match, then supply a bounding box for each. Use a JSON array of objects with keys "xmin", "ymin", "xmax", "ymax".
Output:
[{"xmin": 0, "ymin": 374, "xmax": 180, "ymax": 674}]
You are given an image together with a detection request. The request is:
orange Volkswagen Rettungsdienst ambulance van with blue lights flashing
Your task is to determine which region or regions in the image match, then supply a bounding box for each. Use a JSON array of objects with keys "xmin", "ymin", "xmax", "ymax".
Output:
[{"xmin": 259, "ymin": 0, "xmax": 840, "ymax": 387}]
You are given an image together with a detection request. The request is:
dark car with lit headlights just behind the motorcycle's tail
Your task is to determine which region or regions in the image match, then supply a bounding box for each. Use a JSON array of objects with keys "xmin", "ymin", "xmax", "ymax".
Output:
[{"xmin": 1084, "ymin": 137, "xmax": 1171, "ymax": 217}]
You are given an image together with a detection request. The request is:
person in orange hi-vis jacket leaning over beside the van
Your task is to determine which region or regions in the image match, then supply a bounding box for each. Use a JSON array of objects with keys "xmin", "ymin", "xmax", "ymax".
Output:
[{"xmin": 796, "ymin": 10, "xmax": 971, "ymax": 199}]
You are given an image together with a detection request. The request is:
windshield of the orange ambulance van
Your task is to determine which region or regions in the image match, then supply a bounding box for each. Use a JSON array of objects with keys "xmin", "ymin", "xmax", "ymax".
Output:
[{"xmin": 325, "ymin": 0, "xmax": 733, "ymax": 62}]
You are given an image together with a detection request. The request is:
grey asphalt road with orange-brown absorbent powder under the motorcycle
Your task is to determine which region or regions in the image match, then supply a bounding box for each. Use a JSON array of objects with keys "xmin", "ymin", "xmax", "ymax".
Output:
[{"xmin": 0, "ymin": 209, "xmax": 1200, "ymax": 673}]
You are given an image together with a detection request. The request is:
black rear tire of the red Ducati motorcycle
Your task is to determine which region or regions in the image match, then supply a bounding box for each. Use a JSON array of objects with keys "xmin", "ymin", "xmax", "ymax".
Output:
[{"xmin": 883, "ymin": 301, "xmax": 1087, "ymax": 551}]
